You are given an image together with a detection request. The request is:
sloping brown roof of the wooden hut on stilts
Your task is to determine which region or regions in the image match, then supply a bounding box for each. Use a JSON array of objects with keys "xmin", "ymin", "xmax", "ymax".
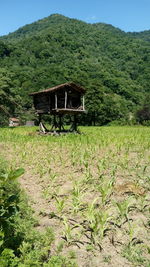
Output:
[{"xmin": 29, "ymin": 82, "xmax": 86, "ymax": 96}]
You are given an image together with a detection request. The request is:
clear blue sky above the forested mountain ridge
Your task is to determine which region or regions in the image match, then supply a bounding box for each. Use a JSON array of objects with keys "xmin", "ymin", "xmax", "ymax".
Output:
[{"xmin": 0, "ymin": 0, "xmax": 150, "ymax": 35}]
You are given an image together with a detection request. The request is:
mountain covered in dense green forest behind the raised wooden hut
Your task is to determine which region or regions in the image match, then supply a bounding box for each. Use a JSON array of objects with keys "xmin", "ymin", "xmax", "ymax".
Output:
[{"xmin": 0, "ymin": 14, "xmax": 150, "ymax": 125}]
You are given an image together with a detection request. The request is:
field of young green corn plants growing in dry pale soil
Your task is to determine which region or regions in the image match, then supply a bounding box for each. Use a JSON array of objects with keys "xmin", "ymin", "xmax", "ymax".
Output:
[{"xmin": 0, "ymin": 127, "xmax": 150, "ymax": 267}]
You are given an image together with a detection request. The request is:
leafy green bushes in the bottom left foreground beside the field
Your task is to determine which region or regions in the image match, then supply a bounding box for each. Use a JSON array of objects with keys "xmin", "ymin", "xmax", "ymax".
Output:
[{"xmin": 0, "ymin": 158, "xmax": 77, "ymax": 267}]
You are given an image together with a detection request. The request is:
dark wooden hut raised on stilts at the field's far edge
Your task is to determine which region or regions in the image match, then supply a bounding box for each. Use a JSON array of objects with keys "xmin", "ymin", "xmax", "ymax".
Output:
[{"xmin": 30, "ymin": 83, "xmax": 85, "ymax": 131}]
